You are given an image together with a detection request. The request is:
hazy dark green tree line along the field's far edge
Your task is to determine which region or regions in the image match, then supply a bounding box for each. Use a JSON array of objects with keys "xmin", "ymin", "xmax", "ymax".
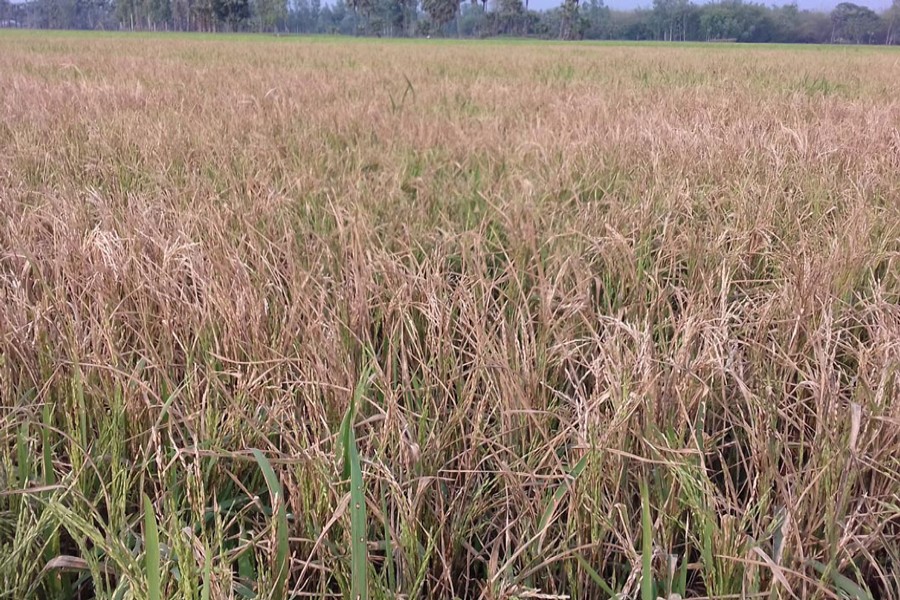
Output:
[{"xmin": 0, "ymin": 0, "xmax": 900, "ymax": 44}]
